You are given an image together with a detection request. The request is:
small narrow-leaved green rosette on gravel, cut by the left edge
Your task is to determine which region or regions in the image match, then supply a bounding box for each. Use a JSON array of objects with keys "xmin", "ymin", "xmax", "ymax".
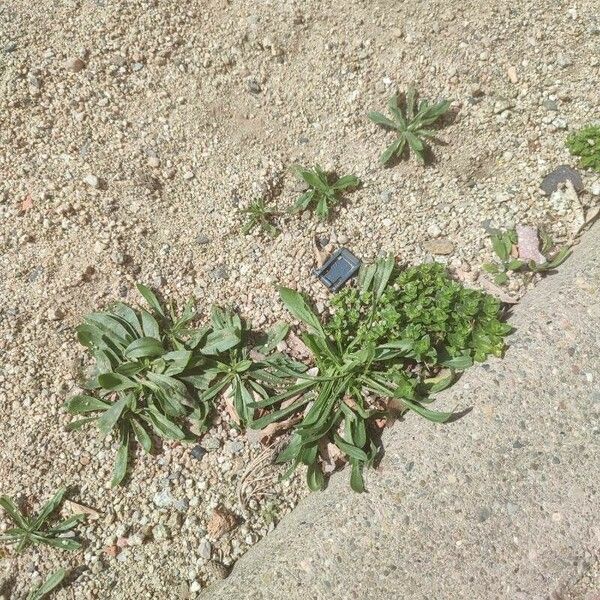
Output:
[{"xmin": 0, "ymin": 488, "xmax": 85, "ymax": 553}]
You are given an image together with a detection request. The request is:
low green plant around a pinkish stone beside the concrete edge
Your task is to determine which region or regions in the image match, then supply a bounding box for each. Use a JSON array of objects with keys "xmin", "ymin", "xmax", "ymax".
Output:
[{"xmin": 483, "ymin": 229, "xmax": 571, "ymax": 285}]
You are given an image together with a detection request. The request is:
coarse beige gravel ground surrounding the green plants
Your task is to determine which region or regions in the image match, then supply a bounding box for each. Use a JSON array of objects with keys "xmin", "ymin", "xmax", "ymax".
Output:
[{"xmin": 0, "ymin": 0, "xmax": 600, "ymax": 598}]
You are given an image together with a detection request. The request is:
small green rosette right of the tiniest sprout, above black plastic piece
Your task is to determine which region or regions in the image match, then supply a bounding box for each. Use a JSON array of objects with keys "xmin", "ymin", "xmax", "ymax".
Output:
[{"xmin": 292, "ymin": 165, "xmax": 360, "ymax": 220}]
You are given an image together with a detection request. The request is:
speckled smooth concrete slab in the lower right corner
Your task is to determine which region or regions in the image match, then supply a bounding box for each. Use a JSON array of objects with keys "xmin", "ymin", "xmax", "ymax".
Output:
[{"xmin": 203, "ymin": 227, "xmax": 600, "ymax": 600}]
